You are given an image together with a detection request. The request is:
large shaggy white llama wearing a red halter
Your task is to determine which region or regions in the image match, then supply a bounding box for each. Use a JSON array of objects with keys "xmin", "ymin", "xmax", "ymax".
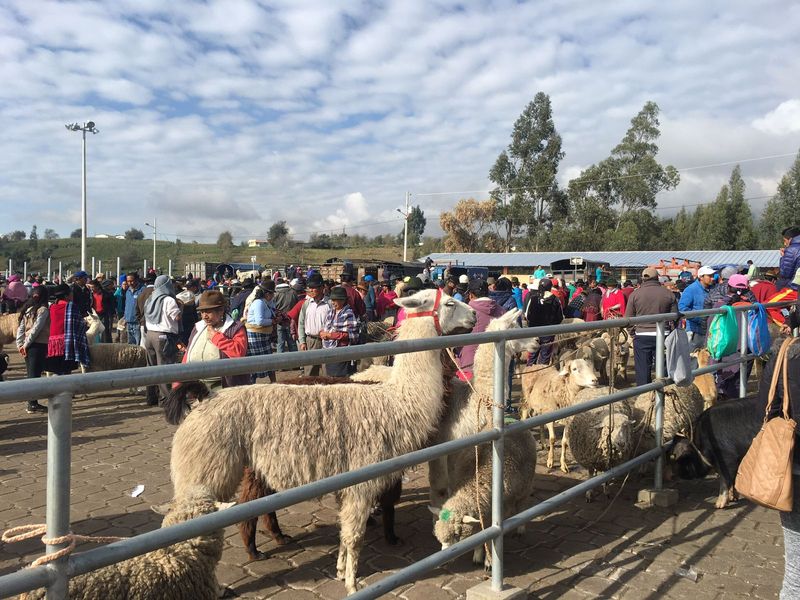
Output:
[{"xmin": 170, "ymin": 290, "xmax": 476, "ymax": 593}]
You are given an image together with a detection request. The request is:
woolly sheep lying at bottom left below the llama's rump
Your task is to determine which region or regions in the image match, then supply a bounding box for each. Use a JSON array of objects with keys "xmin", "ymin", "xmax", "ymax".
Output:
[{"xmin": 28, "ymin": 488, "xmax": 231, "ymax": 600}]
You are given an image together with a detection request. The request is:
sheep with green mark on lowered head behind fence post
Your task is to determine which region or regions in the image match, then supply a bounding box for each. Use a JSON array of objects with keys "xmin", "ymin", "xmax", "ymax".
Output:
[{"xmin": 430, "ymin": 431, "xmax": 537, "ymax": 568}]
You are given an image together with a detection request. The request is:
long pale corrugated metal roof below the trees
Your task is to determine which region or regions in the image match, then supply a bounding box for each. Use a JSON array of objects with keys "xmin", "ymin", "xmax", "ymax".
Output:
[{"xmin": 422, "ymin": 250, "xmax": 781, "ymax": 269}]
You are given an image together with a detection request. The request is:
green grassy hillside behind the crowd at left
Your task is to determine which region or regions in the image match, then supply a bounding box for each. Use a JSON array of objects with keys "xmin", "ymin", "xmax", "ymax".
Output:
[{"xmin": 0, "ymin": 238, "xmax": 403, "ymax": 273}]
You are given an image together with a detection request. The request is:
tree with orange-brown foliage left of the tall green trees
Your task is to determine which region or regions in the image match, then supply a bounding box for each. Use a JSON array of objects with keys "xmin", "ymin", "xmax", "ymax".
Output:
[{"xmin": 439, "ymin": 198, "xmax": 503, "ymax": 252}]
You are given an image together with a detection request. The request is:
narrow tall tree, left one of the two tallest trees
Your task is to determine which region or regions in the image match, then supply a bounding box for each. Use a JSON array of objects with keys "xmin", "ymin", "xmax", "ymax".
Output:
[{"xmin": 489, "ymin": 92, "xmax": 566, "ymax": 252}]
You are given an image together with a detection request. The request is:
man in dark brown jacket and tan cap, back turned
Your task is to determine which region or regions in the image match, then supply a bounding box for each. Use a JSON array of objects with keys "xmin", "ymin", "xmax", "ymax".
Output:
[{"xmin": 625, "ymin": 267, "xmax": 678, "ymax": 385}]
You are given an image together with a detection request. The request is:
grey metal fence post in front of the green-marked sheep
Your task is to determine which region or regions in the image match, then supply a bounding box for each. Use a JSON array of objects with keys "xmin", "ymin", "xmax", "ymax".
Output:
[{"xmin": 492, "ymin": 341, "xmax": 506, "ymax": 592}]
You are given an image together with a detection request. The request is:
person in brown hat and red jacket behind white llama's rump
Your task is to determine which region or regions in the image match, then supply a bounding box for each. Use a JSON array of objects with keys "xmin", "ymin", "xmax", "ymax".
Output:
[{"xmin": 183, "ymin": 290, "xmax": 250, "ymax": 389}]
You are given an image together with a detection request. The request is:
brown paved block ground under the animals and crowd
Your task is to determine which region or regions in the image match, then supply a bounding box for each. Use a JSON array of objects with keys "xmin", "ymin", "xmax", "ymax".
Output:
[{"xmin": 0, "ymin": 353, "xmax": 783, "ymax": 600}]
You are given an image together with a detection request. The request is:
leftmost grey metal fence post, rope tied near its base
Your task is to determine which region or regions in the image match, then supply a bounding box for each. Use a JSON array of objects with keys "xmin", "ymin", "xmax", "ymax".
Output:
[{"xmin": 47, "ymin": 392, "xmax": 72, "ymax": 600}]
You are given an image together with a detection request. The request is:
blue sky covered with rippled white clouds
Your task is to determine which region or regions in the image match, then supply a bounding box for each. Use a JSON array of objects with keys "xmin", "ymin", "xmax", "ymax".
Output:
[{"xmin": 0, "ymin": 0, "xmax": 800, "ymax": 242}]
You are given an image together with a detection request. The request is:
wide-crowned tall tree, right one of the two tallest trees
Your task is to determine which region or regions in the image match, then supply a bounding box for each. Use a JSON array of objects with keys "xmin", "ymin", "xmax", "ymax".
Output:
[{"xmin": 570, "ymin": 102, "xmax": 680, "ymax": 229}]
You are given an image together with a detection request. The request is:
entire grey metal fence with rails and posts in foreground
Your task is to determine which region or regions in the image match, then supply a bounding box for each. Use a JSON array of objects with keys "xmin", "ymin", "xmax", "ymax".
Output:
[{"xmin": 0, "ymin": 302, "xmax": 792, "ymax": 599}]
